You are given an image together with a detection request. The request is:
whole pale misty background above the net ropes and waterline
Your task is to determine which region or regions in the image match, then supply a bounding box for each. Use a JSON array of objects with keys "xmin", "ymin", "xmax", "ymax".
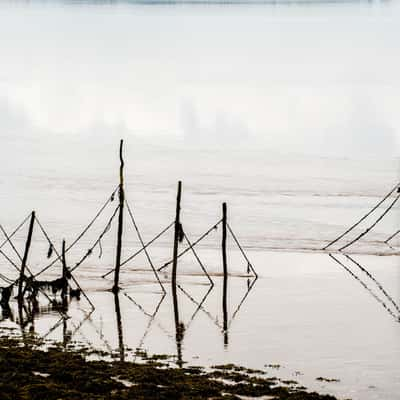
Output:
[{"xmin": 0, "ymin": 1, "xmax": 400, "ymax": 252}]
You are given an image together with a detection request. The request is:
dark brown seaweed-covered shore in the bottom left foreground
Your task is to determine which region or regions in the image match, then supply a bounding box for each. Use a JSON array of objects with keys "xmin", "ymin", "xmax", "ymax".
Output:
[{"xmin": 0, "ymin": 337, "xmax": 335, "ymax": 400}]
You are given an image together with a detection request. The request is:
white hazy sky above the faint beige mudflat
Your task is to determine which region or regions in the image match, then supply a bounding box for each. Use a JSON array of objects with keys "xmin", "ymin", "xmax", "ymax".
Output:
[{"xmin": 0, "ymin": 2, "xmax": 400, "ymax": 156}]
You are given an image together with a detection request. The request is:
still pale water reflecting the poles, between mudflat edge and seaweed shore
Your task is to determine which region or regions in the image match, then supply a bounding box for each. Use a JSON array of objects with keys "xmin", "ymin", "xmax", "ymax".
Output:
[{"xmin": 3, "ymin": 252, "xmax": 400, "ymax": 399}]
